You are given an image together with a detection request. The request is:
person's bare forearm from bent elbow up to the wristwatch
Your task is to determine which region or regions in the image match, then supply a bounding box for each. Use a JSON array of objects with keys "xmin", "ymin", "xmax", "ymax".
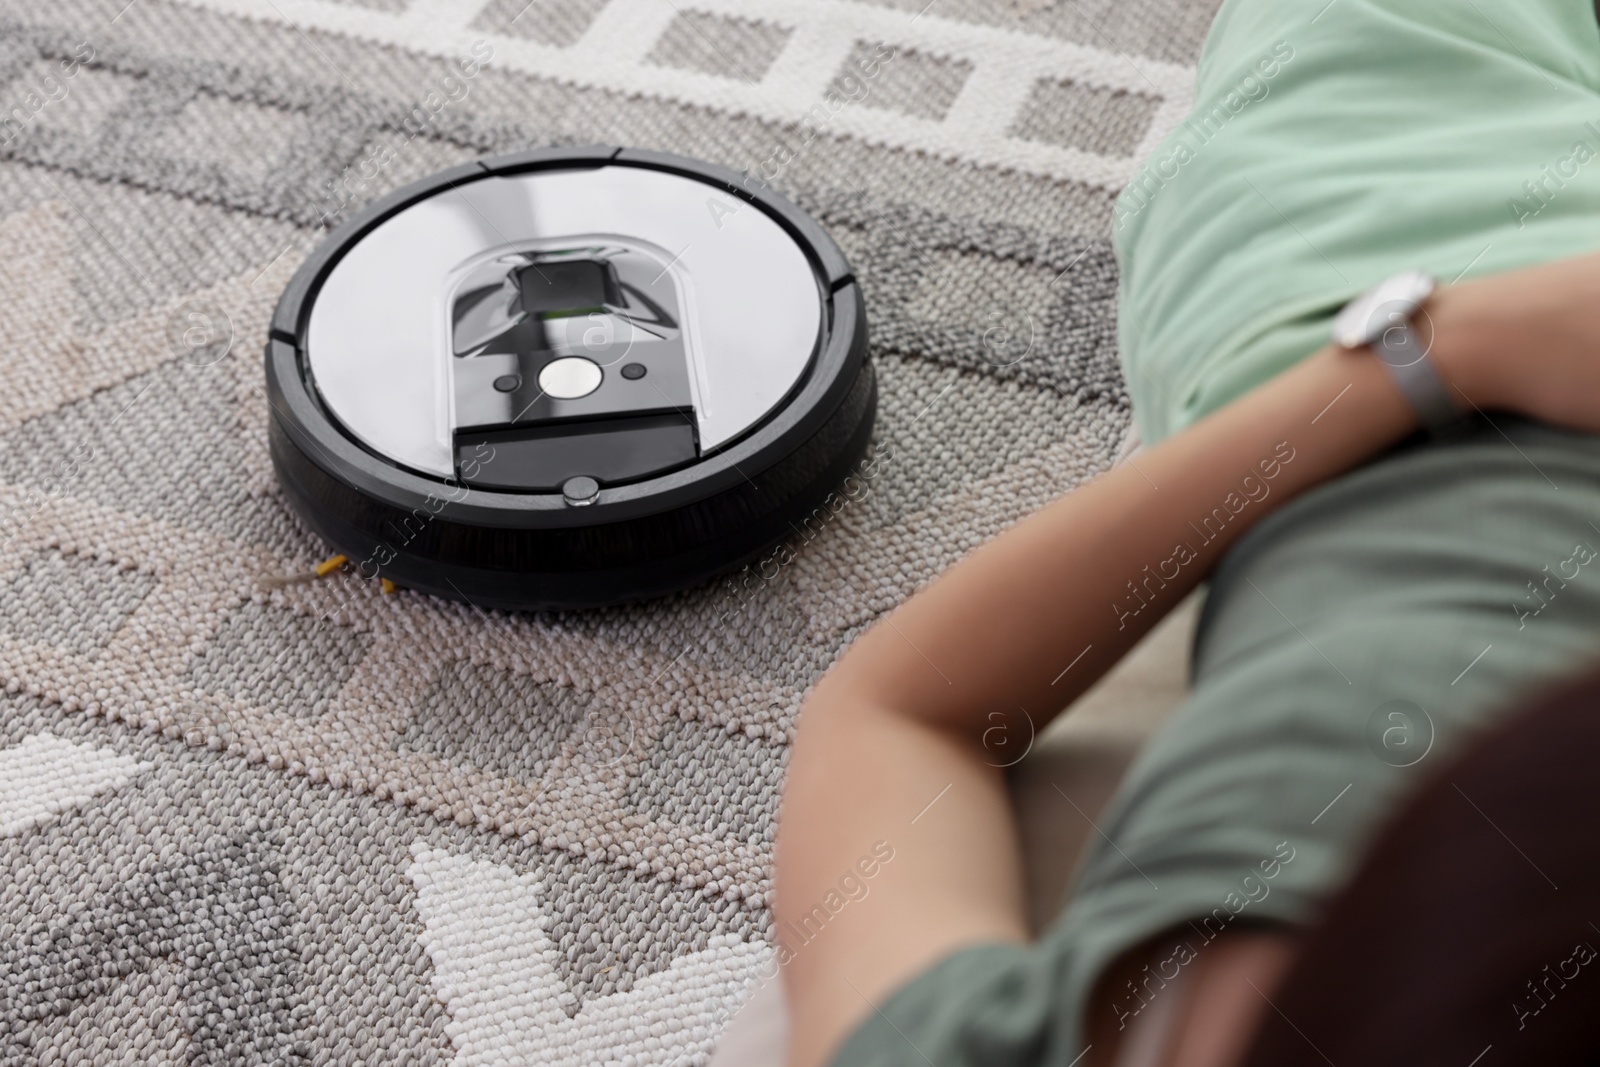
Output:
[{"xmin": 818, "ymin": 340, "xmax": 1418, "ymax": 742}]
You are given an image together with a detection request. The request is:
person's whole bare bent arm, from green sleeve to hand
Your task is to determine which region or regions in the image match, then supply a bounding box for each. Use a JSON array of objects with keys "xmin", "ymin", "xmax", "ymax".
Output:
[{"xmin": 773, "ymin": 256, "xmax": 1600, "ymax": 1067}]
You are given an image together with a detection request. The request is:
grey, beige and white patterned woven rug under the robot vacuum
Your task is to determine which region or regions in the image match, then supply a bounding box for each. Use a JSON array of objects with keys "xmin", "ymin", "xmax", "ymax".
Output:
[{"xmin": 0, "ymin": 0, "xmax": 1216, "ymax": 1065}]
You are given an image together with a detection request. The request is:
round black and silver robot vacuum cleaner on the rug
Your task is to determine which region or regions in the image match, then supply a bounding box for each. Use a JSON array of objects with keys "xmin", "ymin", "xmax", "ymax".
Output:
[{"xmin": 266, "ymin": 147, "xmax": 877, "ymax": 609}]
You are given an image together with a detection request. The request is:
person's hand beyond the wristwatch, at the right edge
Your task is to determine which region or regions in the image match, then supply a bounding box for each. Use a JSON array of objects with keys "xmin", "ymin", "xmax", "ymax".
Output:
[{"xmin": 1426, "ymin": 247, "xmax": 1600, "ymax": 434}]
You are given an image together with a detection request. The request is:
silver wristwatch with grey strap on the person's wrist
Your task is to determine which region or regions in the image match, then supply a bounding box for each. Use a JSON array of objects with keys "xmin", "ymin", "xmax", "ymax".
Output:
[{"xmin": 1333, "ymin": 270, "xmax": 1466, "ymax": 432}]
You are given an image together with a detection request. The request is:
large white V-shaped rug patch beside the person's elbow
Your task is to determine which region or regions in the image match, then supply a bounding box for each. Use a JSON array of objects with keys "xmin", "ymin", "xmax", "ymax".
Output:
[{"xmin": 406, "ymin": 845, "xmax": 771, "ymax": 1067}]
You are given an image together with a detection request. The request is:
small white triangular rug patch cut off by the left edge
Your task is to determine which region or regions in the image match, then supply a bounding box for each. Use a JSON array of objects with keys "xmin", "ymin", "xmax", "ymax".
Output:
[{"xmin": 0, "ymin": 734, "xmax": 149, "ymax": 837}]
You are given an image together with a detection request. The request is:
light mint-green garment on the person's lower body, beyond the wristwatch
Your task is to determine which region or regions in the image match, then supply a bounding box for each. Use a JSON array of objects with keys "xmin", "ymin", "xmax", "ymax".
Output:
[{"xmin": 1114, "ymin": 0, "xmax": 1600, "ymax": 442}]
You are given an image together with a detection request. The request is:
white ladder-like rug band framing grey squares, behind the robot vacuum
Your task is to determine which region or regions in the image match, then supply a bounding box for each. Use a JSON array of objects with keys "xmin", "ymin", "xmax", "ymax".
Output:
[{"xmin": 182, "ymin": 0, "xmax": 1194, "ymax": 189}]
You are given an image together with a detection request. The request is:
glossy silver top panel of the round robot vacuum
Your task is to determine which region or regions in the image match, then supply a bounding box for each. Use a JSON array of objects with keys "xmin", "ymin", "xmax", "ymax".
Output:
[{"xmin": 306, "ymin": 165, "xmax": 822, "ymax": 477}]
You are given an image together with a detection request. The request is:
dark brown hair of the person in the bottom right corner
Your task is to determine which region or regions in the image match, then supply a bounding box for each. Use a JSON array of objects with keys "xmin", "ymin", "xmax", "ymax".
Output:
[{"xmin": 1240, "ymin": 662, "xmax": 1600, "ymax": 1067}]
